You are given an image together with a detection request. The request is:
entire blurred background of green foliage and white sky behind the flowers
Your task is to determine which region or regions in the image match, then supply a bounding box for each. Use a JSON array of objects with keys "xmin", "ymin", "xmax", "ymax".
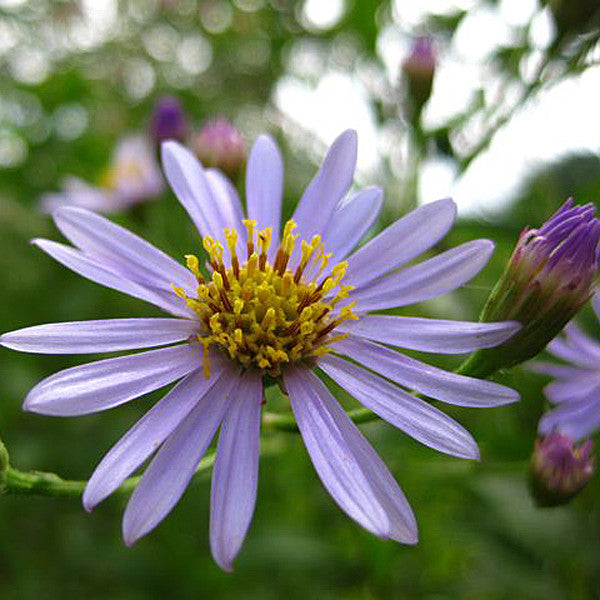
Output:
[{"xmin": 0, "ymin": 0, "xmax": 600, "ymax": 600}]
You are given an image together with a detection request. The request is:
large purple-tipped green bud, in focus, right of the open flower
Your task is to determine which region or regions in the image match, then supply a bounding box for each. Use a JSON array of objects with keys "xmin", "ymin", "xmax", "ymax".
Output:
[{"xmin": 461, "ymin": 199, "xmax": 600, "ymax": 377}]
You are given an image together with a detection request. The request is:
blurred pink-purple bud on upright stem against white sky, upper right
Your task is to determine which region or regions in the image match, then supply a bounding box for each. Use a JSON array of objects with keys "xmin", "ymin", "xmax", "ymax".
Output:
[{"xmin": 402, "ymin": 38, "xmax": 436, "ymax": 118}]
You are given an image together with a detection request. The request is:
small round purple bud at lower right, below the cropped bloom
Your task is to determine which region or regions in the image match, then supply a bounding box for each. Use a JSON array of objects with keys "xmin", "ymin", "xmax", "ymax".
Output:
[{"xmin": 530, "ymin": 432, "xmax": 595, "ymax": 506}]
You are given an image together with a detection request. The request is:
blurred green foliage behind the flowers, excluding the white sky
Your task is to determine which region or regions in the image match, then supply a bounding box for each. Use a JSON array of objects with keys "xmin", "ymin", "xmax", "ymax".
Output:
[{"xmin": 0, "ymin": 0, "xmax": 600, "ymax": 600}]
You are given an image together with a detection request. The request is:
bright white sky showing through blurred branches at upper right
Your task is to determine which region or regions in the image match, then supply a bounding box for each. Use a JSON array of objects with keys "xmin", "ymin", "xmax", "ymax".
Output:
[{"xmin": 275, "ymin": 0, "xmax": 600, "ymax": 216}]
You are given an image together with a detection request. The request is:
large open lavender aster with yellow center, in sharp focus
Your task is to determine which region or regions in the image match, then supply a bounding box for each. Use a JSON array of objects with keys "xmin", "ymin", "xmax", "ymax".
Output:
[{"xmin": 0, "ymin": 131, "xmax": 518, "ymax": 569}]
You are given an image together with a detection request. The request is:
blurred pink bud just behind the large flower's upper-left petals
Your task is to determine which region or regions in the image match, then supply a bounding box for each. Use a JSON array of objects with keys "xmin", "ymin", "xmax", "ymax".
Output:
[{"xmin": 192, "ymin": 118, "xmax": 246, "ymax": 180}]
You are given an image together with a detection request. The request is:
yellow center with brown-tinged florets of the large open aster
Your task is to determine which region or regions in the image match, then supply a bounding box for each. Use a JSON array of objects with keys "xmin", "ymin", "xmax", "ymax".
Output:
[{"xmin": 174, "ymin": 221, "xmax": 358, "ymax": 378}]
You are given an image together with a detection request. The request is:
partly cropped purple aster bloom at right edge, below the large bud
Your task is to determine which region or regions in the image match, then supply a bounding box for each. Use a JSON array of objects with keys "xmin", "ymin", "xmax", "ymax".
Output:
[{"xmin": 530, "ymin": 295, "xmax": 600, "ymax": 441}]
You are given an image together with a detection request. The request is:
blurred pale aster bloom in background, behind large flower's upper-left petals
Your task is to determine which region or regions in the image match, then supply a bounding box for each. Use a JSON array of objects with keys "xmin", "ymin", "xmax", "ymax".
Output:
[{"xmin": 40, "ymin": 136, "xmax": 164, "ymax": 213}]
